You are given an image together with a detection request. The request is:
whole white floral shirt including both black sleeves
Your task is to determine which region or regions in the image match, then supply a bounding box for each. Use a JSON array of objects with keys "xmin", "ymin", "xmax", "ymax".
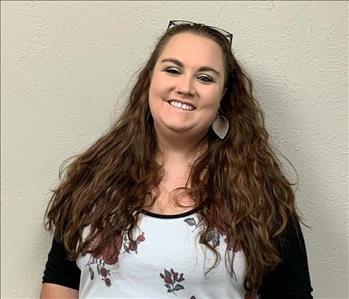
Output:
[{"xmin": 42, "ymin": 209, "xmax": 313, "ymax": 299}]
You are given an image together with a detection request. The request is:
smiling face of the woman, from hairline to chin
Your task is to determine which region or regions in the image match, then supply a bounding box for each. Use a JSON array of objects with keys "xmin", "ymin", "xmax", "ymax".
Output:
[{"xmin": 149, "ymin": 32, "xmax": 224, "ymax": 137}]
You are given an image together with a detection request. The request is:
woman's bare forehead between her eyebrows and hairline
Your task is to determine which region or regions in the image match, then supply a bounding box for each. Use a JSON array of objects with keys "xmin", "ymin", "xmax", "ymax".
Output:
[{"xmin": 158, "ymin": 32, "xmax": 224, "ymax": 71}]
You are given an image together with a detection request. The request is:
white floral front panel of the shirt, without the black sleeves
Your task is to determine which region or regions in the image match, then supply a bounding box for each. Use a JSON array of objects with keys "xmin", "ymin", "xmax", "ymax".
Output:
[{"xmin": 76, "ymin": 211, "xmax": 252, "ymax": 299}]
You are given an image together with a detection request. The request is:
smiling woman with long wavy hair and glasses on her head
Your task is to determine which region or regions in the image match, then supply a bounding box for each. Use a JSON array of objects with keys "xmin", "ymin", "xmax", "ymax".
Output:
[{"xmin": 41, "ymin": 21, "xmax": 312, "ymax": 299}]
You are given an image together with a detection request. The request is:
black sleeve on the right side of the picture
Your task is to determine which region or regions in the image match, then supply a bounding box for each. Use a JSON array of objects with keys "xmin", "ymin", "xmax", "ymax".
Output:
[{"xmin": 259, "ymin": 220, "xmax": 313, "ymax": 299}]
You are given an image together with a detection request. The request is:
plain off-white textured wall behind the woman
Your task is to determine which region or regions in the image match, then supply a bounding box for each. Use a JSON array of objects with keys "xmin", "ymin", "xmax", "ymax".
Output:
[{"xmin": 1, "ymin": 1, "xmax": 348, "ymax": 299}]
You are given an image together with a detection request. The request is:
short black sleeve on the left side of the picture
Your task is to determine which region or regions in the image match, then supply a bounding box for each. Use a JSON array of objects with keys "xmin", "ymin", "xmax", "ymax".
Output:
[{"xmin": 42, "ymin": 237, "xmax": 81, "ymax": 290}]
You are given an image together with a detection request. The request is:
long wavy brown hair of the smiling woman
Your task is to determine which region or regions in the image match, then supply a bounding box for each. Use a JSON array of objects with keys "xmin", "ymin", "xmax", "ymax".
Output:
[{"xmin": 44, "ymin": 25, "xmax": 300, "ymax": 290}]
